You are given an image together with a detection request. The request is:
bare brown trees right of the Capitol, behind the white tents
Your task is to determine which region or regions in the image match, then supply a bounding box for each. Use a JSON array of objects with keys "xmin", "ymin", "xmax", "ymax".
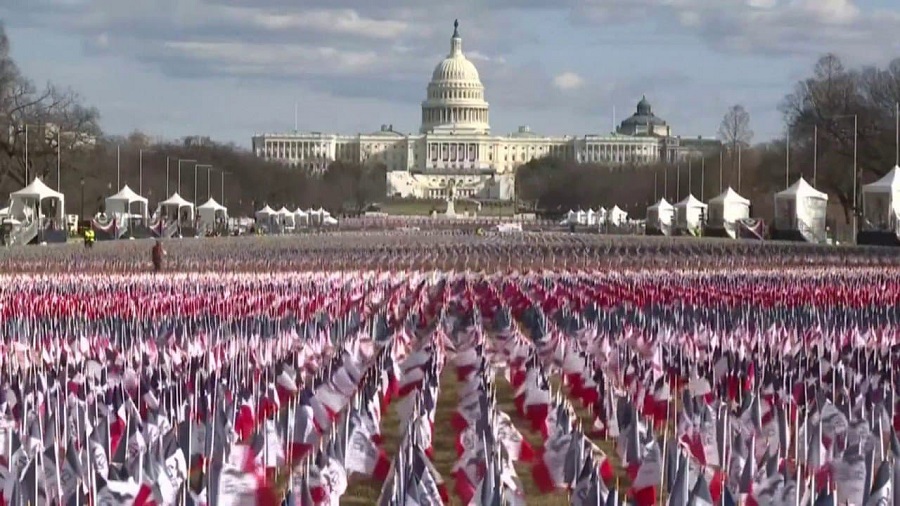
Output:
[{"xmin": 517, "ymin": 54, "xmax": 900, "ymax": 240}]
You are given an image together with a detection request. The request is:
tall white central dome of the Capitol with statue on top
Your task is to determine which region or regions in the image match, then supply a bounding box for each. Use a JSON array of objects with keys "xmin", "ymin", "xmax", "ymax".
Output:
[{"xmin": 421, "ymin": 21, "xmax": 490, "ymax": 133}]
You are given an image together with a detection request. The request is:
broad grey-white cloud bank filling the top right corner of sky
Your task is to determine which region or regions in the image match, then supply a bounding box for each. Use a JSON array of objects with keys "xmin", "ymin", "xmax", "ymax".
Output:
[{"xmin": 572, "ymin": 0, "xmax": 900, "ymax": 60}]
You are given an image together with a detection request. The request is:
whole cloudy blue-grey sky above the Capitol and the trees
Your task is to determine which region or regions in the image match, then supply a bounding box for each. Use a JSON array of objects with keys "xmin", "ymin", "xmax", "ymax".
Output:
[{"xmin": 0, "ymin": 0, "xmax": 900, "ymax": 147}]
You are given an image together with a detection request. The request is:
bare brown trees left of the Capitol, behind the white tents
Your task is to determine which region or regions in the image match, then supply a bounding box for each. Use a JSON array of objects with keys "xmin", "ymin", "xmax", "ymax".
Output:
[{"xmin": 0, "ymin": 25, "xmax": 386, "ymax": 216}]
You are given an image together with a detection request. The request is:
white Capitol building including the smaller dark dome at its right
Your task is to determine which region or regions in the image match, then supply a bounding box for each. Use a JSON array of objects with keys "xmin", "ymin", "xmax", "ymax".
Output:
[{"xmin": 253, "ymin": 23, "xmax": 718, "ymax": 200}]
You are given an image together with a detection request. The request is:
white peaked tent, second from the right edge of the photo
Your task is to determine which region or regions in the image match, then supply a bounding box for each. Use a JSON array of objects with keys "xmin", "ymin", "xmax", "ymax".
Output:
[{"xmin": 775, "ymin": 177, "xmax": 828, "ymax": 236}]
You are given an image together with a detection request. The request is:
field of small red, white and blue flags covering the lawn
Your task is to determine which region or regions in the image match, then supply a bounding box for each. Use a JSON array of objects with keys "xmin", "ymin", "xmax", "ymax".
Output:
[{"xmin": 0, "ymin": 234, "xmax": 900, "ymax": 506}]
